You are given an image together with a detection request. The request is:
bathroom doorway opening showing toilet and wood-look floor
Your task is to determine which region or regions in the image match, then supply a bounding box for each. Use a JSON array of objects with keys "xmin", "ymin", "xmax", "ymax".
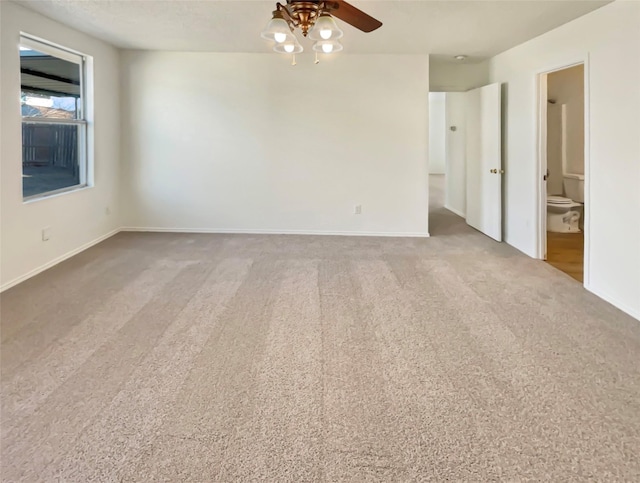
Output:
[{"xmin": 540, "ymin": 63, "xmax": 588, "ymax": 283}]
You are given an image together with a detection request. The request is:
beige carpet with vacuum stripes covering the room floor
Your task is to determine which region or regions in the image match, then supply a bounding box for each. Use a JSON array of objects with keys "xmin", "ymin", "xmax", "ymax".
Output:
[{"xmin": 1, "ymin": 176, "xmax": 640, "ymax": 482}]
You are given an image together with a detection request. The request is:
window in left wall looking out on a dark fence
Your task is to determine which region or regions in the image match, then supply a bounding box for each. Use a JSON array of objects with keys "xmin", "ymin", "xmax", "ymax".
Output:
[{"xmin": 20, "ymin": 36, "xmax": 87, "ymax": 200}]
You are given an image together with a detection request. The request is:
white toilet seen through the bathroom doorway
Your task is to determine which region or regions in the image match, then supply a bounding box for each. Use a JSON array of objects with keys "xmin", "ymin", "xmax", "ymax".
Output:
[{"xmin": 547, "ymin": 173, "xmax": 584, "ymax": 233}]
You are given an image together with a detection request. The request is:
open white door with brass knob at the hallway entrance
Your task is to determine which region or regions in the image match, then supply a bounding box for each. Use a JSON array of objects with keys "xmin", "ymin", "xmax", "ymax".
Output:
[{"xmin": 465, "ymin": 83, "xmax": 503, "ymax": 241}]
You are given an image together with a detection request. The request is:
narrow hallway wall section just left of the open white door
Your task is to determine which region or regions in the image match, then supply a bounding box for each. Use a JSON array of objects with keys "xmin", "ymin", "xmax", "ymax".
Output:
[{"xmin": 444, "ymin": 92, "xmax": 467, "ymax": 217}]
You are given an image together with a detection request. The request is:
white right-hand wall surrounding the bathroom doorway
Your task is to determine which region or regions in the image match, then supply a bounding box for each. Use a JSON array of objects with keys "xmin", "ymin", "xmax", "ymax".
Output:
[{"xmin": 491, "ymin": 1, "xmax": 640, "ymax": 318}]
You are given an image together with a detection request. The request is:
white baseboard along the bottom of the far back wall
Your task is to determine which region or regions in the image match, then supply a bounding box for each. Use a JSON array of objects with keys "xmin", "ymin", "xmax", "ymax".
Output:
[{"xmin": 120, "ymin": 226, "xmax": 429, "ymax": 238}]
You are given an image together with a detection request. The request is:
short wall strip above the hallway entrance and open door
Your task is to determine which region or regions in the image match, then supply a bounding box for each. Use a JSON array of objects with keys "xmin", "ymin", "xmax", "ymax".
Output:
[{"xmin": 429, "ymin": 57, "xmax": 489, "ymax": 92}]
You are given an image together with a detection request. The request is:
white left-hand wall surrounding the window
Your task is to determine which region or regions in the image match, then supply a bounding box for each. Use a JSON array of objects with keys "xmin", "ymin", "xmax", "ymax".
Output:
[{"xmin": 0, "ymin": 1, "xmax": 120, "ymax": 288}]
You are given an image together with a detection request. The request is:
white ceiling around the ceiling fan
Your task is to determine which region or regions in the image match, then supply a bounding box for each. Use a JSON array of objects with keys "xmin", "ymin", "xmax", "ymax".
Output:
[{"xmin": 16, "ymin": 0, "xmax": 609, "ymax": 59}]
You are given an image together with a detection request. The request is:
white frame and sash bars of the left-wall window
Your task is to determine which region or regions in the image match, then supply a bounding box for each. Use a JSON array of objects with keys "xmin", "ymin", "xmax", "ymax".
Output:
[{"xmin": 20, "ymin": 33, "xmax": 93, "ymax": 203}]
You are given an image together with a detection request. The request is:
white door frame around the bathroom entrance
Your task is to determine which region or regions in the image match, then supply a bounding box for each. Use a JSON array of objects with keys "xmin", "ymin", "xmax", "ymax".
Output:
[{"xmin": 535, "ymin": 54, "xmax": 592, "ymax": 288}]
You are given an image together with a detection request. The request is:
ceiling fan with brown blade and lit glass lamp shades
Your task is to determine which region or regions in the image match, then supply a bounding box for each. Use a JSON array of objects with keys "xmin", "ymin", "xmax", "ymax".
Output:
[{"xmin": 260, "ymin": 0, "xmax": 382, "ymax": 54}]
